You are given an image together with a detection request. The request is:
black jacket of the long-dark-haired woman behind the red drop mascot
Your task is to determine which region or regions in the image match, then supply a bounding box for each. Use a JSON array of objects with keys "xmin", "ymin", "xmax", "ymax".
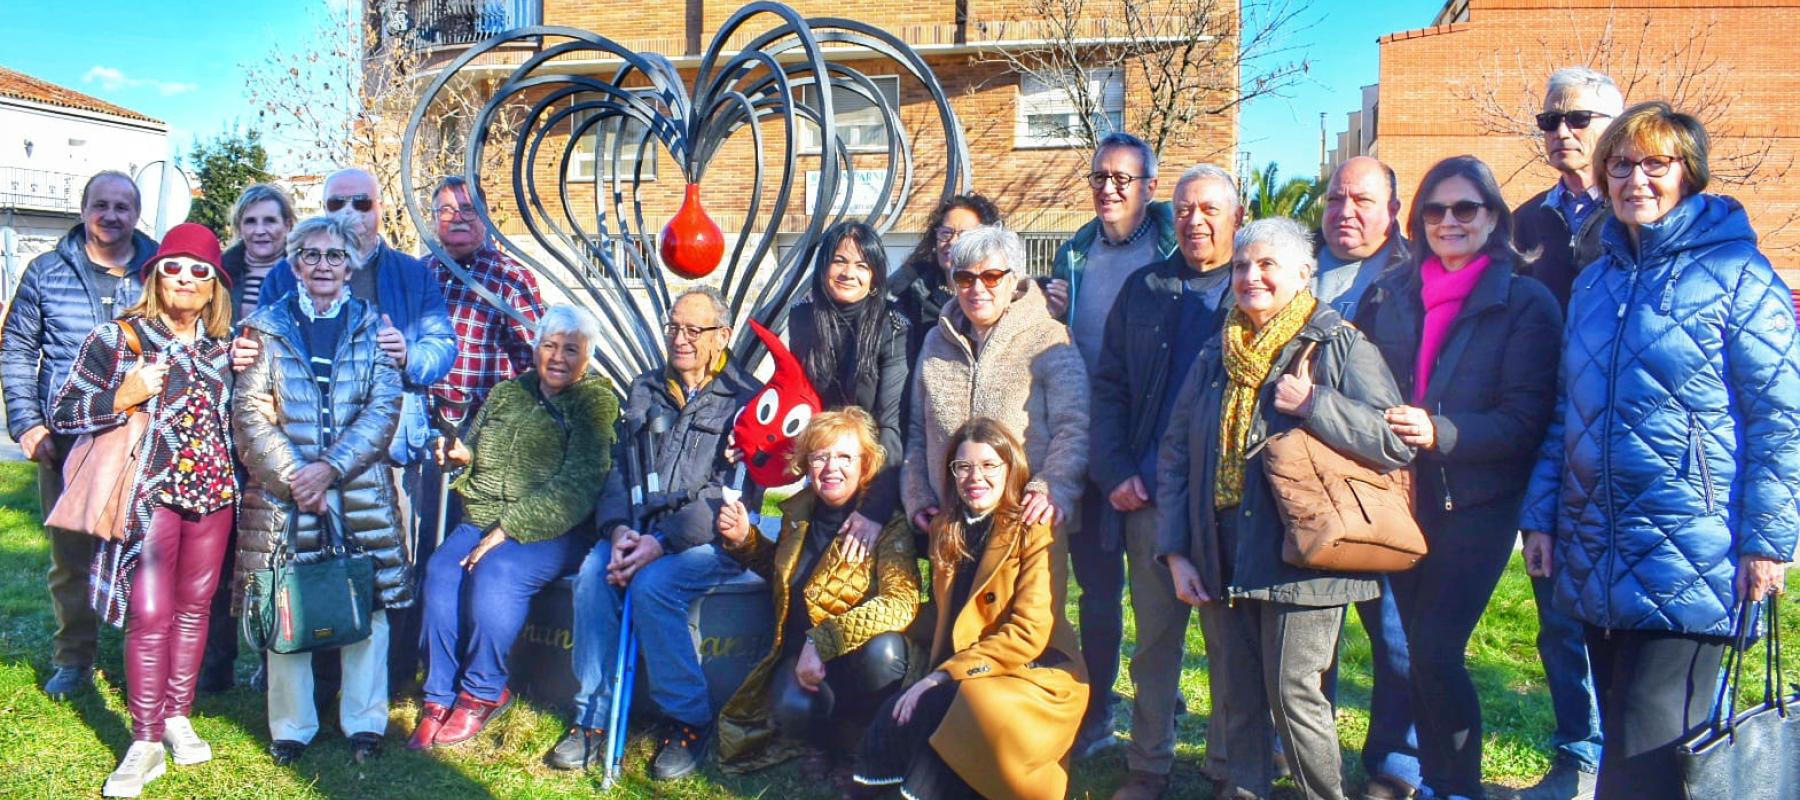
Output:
[{"xmin": 787, "ymin": 303, "xmax": 913, "ymax": 523}]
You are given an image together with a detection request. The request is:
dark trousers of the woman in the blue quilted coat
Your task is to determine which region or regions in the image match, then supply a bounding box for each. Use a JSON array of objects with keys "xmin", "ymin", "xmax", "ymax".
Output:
[{"xmin": 1588, "ymin": 625, "xmax": 1728, "ymax": 800}]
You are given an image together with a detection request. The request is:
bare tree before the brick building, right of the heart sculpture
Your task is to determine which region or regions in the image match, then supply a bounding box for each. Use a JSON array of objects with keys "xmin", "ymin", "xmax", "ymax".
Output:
[{"xmin": 976, "ymin": 0, "xmax": 1310, "ymax": 155}]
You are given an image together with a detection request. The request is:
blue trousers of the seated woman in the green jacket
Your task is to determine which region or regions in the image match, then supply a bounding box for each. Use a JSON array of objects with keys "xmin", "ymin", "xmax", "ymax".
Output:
[{"xmin": 419, "ymin": 524, "xmax": 589, "ymax": 708}]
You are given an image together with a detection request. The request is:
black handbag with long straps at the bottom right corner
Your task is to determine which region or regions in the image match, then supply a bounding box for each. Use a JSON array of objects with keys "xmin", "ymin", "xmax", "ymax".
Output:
[{"xmin": 1676, "ymin": 595, "xmax": 1800, "ymax": 800}]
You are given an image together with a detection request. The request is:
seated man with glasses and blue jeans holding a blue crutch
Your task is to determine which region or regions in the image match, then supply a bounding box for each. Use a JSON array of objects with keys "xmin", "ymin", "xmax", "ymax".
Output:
[{"xmin": 545, "ymin": 286, "xmax": 761, "ymax": 780}]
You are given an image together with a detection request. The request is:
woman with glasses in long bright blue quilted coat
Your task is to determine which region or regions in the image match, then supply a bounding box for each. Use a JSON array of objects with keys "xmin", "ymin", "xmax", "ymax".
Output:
[{"xmin": 1519, "ymin": 103, "xmax": 1800, "ymax": 798}]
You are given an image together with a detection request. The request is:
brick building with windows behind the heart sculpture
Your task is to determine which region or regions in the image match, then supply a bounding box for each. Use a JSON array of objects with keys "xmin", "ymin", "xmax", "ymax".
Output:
[{"xmin": 385, "ymin": 0, "xmax": 1237, "ymax": 279}]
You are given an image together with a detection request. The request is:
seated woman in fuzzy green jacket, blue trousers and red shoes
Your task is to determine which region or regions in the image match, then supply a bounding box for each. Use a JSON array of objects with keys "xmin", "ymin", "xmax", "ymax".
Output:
[{"xmin": 407, "ymin": 306, "xmax": 619, "ymax": 750}]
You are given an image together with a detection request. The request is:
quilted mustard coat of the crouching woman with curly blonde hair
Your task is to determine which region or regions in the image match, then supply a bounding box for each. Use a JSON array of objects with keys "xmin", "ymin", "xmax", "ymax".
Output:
[{"xmin": 718, "ymin": 488, "xmax": 918, "ymax": 771}]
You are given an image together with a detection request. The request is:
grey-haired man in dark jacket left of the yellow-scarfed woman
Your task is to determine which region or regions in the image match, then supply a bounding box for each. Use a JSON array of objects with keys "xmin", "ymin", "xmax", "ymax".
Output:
[{"xmin": 1082, "ymin": 164, "xmax": 1244, "ymax": 800}]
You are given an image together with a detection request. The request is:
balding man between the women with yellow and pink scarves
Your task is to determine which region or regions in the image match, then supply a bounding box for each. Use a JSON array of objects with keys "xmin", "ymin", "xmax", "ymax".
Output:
[{"xmin": 1312, "ymin": 155, "xmax": 1418, "ymax": 800}]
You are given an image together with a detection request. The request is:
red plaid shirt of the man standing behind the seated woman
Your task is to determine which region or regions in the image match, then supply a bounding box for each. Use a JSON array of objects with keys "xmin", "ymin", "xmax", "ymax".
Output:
[{"xmin": 425, "ymin": 245, "xmax": 544, "ymax": 425}]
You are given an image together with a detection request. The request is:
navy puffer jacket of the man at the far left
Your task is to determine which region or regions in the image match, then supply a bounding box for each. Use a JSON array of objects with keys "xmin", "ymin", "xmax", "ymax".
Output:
[{"xmin": 0, "ymin": 223, "xmax": 157, "ymax": 441}]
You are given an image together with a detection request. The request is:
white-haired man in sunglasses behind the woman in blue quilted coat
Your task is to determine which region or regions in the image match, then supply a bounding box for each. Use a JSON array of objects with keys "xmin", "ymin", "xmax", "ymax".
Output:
[{"xmin": 1512, "ymin": 67, "xmax": 1625, "ymax": 800}]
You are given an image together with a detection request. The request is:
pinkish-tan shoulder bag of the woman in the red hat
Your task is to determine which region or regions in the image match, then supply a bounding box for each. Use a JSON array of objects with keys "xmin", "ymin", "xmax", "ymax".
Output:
[{"xmin": 43, "ymin": 321, "xmax": 149, "ymax": 541}]
